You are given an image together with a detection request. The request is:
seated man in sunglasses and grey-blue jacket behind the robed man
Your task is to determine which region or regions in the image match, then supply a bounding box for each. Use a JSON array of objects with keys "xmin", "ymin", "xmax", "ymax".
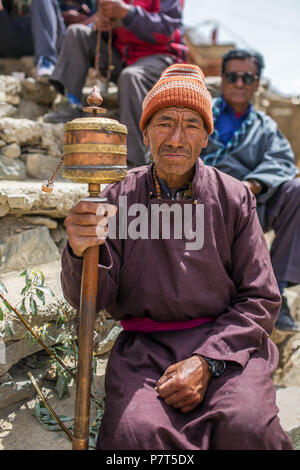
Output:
[{"xmin": 201, "ymin": 49, "xmax": 300, "ymax": 332}]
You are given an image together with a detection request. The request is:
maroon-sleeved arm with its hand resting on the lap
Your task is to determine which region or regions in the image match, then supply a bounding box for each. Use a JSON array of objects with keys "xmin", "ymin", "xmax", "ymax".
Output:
[{"xmin": 157, "ymin": 185, "xmax": 281, "ymax": 413}]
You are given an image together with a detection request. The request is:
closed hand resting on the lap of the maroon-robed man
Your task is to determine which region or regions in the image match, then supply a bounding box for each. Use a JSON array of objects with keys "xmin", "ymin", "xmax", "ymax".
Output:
[{"xmin": 156, "ymin": 355, "xmax": 212, "ymax": 413}]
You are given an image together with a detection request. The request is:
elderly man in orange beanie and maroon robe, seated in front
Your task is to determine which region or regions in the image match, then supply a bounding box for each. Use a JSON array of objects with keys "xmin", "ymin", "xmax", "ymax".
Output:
[{"xmin": 62, "ymin": 64, "xmax": 292, "ymax": 450}]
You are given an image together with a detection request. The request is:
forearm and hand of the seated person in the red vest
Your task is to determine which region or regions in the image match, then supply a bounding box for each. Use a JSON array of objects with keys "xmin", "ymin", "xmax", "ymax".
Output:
[{"xmin": 101, "ymin": 0, "xmax": 182, "ymax": 44}]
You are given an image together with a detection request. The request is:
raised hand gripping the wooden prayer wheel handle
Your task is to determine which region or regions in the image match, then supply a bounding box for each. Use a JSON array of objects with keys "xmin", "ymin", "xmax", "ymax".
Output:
[{"xmin": 65, "ymin": 201, "xmax": 117, "ymax": 257}]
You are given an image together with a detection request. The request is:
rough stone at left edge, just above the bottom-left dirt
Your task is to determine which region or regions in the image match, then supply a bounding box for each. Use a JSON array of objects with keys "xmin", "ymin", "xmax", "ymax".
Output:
[{"xmin": 0, "ymin": 367, "xmax": 45, "ymax": 409}]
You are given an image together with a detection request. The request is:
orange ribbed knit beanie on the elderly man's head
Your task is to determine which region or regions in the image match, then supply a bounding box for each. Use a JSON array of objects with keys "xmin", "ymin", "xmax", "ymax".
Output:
[{"xmin": 140, "ymin": 64, "xmax": 214, "ymax": 135}]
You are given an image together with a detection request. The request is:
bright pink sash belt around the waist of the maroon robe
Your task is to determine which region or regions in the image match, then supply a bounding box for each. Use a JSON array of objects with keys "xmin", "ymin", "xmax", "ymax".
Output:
[{"xmin": 120, "ymin": 317, "xmax": 215, "ymax": 333}]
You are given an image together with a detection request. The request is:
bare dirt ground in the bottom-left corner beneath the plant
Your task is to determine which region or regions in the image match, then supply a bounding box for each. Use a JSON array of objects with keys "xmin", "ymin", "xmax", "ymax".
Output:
[{"xmin": 0, "ymin": 357, "xmax": 107, "ymax": 450}]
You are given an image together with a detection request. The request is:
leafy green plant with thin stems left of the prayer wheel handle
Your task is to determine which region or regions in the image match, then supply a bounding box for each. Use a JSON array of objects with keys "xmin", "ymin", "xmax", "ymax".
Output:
[{"xmin": 0, "ymin": 269, "xmax": 104, "ymax": 449}]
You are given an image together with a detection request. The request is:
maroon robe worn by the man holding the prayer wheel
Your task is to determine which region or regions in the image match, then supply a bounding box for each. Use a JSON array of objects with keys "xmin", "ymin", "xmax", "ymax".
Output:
[{"xmin": 62, "ymin": 160, "xmax": 292, "ymax": 450}]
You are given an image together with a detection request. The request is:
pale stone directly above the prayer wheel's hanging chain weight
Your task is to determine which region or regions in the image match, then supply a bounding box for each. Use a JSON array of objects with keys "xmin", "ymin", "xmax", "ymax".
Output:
[{"xmin": 25, "ymin": 153, "xmax": 62, "ymax": 180}]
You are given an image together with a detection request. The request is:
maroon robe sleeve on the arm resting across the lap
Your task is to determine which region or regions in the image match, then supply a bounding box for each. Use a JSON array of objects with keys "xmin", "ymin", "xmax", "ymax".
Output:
[{"xmin": 194, "ymin": 189, "xmax": 281, "ymax": 367}]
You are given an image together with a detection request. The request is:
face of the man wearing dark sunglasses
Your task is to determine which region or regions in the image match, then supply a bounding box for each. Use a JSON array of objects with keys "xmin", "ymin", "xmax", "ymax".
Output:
[{"xmin": 222, "ymin": 59, "xmax": 259, "ymax": 108}]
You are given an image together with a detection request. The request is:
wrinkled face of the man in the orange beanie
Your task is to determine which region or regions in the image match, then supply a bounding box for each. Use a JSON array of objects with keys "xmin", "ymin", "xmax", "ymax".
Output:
[{"xmin": 143, "ymin": 106, "xmax": 207, "ymax": 175}]
